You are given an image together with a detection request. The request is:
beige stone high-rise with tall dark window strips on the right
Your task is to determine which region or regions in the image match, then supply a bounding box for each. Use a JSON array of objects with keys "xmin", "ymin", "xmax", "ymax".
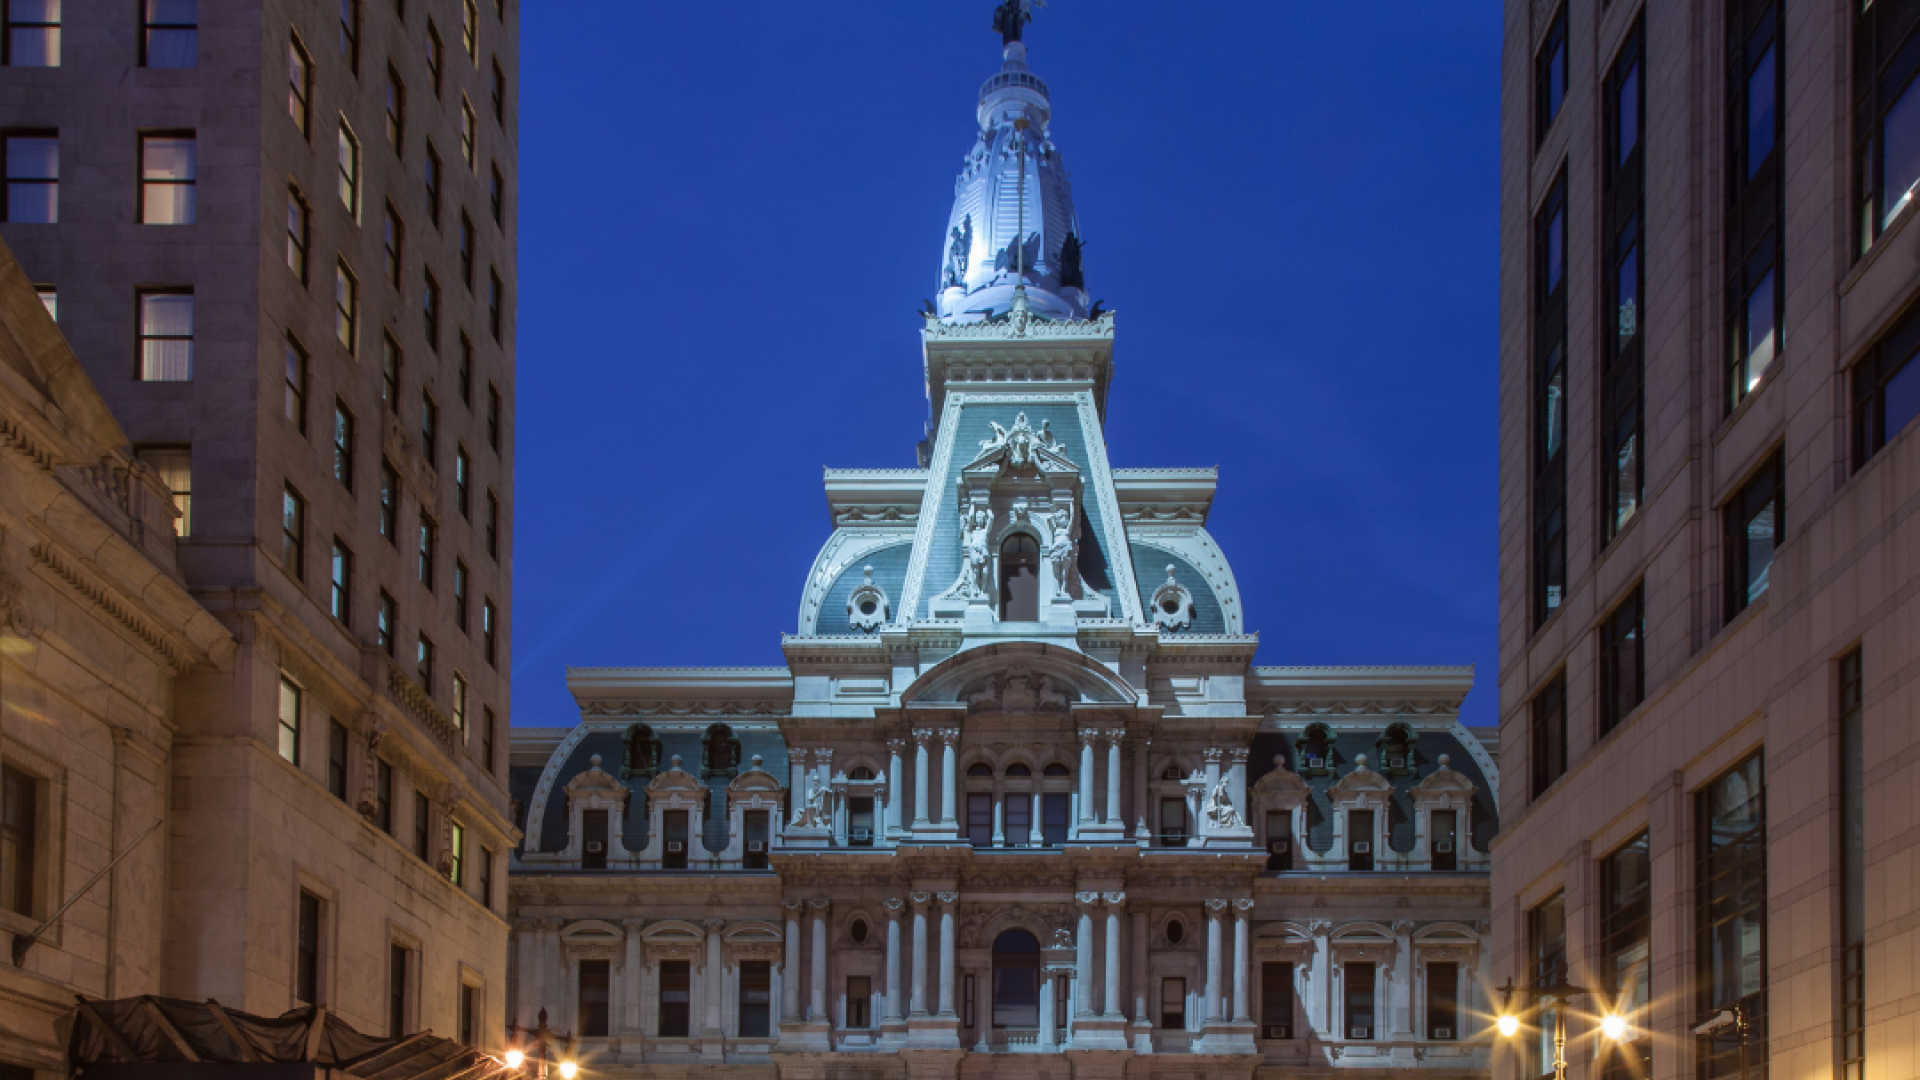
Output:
[{"xmin": 1494, "ymin": 0, "xmax": 1920, "ymax": 1080}]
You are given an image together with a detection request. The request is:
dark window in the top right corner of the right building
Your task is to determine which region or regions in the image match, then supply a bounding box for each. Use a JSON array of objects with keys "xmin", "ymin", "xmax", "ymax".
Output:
[{"xmin": 1851, "ymin": 4, "xmax": 1920, "ymax": 254}]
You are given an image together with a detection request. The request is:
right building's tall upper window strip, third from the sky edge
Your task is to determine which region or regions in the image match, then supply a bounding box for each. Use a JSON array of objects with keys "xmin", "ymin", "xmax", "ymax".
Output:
[{"xmin": 1722, "ymin": 0, "xmax": 1786, "ymax": 409}]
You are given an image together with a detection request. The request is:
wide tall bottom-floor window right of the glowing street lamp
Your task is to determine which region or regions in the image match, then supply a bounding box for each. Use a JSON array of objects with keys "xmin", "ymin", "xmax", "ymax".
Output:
[{"xmin": 1693, "ymin": 753, "xmax": 1768, "ymax": 1080}]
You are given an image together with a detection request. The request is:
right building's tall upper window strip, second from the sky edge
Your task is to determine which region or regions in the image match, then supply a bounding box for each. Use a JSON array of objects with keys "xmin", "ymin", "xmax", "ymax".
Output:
[{"xmin": 1599, "ymin": 23, "xmax": 1647, "ymax": 544}]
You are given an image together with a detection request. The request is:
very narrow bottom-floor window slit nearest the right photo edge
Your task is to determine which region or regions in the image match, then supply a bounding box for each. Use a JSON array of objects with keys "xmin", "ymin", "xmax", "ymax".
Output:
[{"xmin": 1839, "ymin": 650, "xmax": 1866, "ymax": 1080}]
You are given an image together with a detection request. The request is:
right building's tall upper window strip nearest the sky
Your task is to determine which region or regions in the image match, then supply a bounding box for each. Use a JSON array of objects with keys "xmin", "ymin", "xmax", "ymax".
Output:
[{"xmin": 1532, "ymin": 171, "xmax": 1567, "ymax": 626}]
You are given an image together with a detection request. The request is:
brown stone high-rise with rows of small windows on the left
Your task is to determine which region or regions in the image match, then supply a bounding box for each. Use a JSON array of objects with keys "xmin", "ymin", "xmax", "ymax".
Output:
[{"xmin": 0, "ymin": 0, "xmax": 518, "ymax": 1042}]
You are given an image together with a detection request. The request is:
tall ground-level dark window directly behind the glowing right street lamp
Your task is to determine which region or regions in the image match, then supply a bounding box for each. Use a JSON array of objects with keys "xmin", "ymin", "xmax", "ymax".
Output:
[{"xmin": 1599, "ymin": 832, "xmax": 1653, "ymax": 1080}]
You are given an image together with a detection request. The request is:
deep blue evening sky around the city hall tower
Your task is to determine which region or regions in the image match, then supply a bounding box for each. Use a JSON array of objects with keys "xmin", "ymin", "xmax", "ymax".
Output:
[{"xmin": 513, "ymin": 0, "xmax": 1501, "ymax": 724}]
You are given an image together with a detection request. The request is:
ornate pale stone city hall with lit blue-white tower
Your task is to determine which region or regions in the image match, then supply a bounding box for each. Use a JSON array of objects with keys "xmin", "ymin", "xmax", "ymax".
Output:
[{"xmin": 507, "ymin": 16, "xmax": 1500, "ymax": 1078}]
